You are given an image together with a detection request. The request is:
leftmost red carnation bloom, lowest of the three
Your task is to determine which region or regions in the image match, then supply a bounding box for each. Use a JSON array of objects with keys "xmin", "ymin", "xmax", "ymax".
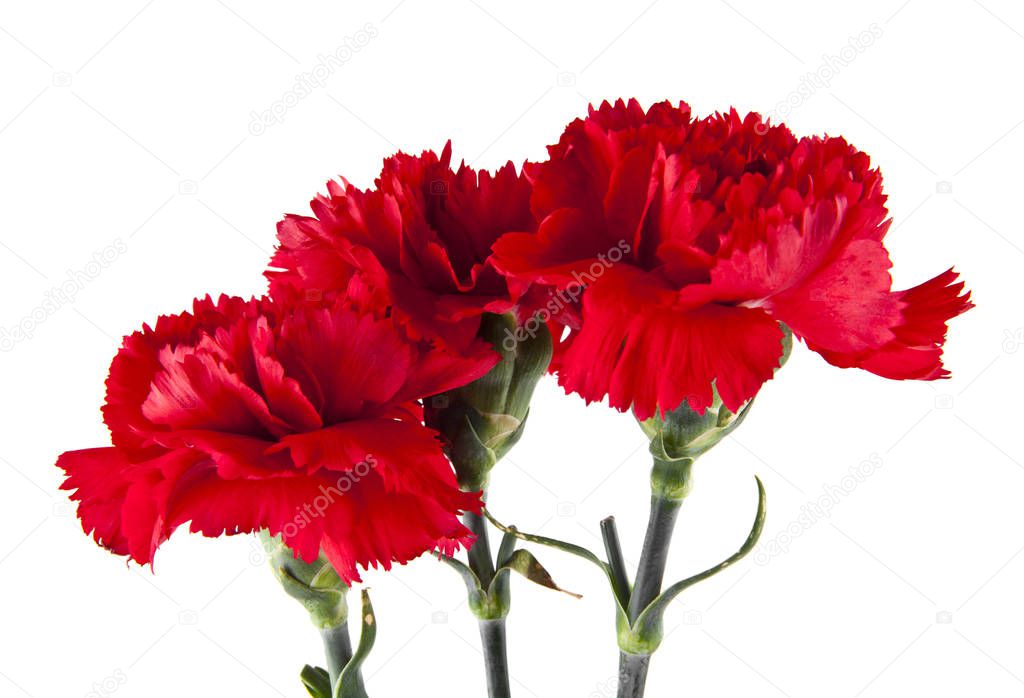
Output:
[{"xmin": 57, "ymin": 290, "xmax": 497, "ymax": 582}]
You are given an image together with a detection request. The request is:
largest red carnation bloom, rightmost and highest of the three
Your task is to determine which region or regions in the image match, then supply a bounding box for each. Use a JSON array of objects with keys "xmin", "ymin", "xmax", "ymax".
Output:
[{"xmin": 494, "ymin": 100, "xmax": 971, "ymax": 419}]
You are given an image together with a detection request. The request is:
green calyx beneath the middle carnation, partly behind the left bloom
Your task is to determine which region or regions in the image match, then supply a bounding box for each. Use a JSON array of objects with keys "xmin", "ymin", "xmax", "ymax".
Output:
[{"xmin": 426, "ymin": 313, "xmax": 552, "ymax": 490}]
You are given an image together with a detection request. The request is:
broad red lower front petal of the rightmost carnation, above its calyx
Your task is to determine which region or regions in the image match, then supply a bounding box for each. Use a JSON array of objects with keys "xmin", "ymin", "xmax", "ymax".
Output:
[{"xmin": 559, "ymin": 268, "xmax": 782, "ymax": 419}]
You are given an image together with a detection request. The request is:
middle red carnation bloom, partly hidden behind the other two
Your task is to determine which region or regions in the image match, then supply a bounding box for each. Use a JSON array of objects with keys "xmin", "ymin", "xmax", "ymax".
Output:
[{"xmin": 267, "ymin": 142, "xmax": 534, "ymax": 346}]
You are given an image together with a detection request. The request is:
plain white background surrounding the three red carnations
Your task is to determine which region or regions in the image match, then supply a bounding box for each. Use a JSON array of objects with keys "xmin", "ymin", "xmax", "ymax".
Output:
[{"xmin": 0, "ymin": 0, "xmax": 1024, "ymax": 698}]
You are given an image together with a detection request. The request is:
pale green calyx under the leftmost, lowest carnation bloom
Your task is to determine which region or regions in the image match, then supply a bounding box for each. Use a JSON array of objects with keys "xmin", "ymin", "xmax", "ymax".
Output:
[{"xmin": 260, "ymin": 531, "xmax": 348, "ymax": 629}]
